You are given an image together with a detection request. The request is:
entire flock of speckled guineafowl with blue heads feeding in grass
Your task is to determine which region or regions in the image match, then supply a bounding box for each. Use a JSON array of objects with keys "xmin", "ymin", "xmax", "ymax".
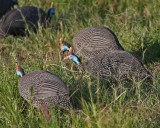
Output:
[{"xmin": 0, "ymin": 0, "xmax": 152, "ymax": 119}]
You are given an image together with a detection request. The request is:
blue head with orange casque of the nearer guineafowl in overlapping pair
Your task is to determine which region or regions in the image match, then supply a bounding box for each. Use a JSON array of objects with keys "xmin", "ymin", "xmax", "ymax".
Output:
[{"xmin": 64, "ymin": 47, "xmax": 81, "ymax": 65}]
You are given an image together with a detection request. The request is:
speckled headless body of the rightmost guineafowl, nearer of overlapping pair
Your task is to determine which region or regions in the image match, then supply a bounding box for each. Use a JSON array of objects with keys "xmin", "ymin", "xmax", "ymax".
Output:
[{"xmin": 84, "ymin": 50, "xmax": 151, "ymax": 81}]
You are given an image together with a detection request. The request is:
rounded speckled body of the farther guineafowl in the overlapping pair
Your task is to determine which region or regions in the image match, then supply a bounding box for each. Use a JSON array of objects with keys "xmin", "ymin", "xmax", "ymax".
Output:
[{"xmin": 73, "ymin": 26, "xmax": 124, "ymax": 59}]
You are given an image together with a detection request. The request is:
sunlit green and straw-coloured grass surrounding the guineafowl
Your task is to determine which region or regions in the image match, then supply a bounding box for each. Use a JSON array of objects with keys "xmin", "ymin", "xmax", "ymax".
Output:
[{"xmin": 0, "ymin": 0, "xmax": 160, "ymax": 128}]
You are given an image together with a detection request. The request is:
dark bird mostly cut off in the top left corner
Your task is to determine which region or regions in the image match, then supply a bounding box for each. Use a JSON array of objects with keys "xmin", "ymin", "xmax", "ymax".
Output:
[{"xmin": 0, "ymin": 0, "xmax": 18, "ymax": 18}]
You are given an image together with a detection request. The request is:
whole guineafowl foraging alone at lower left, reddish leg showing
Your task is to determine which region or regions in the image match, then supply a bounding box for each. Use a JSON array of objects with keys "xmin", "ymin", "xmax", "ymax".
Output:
[{"xmin": 16, "ymin": 63, "xmax": 69, "ymax": 119}]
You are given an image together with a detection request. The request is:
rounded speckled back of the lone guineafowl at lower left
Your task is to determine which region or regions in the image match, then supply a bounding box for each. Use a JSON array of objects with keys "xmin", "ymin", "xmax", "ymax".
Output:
[{"xmin": 18, "ymin": 70, "xmax": 69, "ymax": 107}]
